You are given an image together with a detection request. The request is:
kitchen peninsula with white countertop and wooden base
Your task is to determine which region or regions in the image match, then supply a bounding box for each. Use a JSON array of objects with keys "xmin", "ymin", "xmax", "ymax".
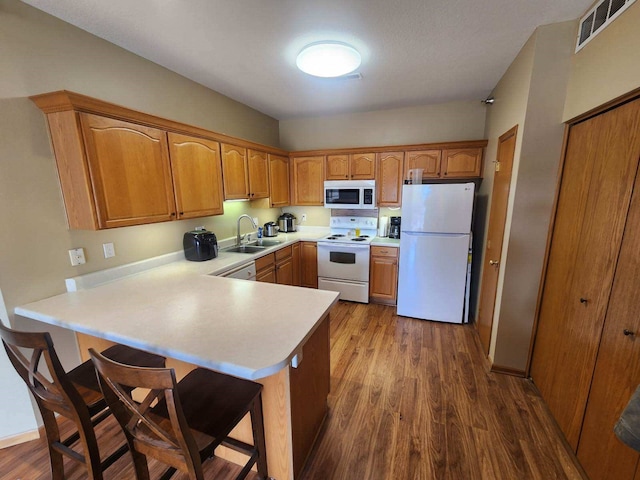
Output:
[{"xmin": 15, "ymin": 248, "xmax": 338, "ymax": 480}]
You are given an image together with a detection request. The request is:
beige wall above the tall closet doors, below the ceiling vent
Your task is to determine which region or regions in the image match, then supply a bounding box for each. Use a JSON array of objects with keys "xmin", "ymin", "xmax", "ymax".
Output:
[{"xmin": 563, "ymin": 2, "xmax": 640, "ymax": 121}]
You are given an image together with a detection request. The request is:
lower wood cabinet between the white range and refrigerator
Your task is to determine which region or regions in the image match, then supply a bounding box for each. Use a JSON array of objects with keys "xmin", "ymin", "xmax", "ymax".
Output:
[{"xmin": 369, "ymin": 245, "xmax": 398, "ymax": 305}]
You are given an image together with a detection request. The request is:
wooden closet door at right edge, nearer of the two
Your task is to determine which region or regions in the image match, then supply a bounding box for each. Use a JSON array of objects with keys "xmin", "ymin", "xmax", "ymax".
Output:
[{"xmin": 578, "ymin": 166, "xmax": 640, "ymax": 480}]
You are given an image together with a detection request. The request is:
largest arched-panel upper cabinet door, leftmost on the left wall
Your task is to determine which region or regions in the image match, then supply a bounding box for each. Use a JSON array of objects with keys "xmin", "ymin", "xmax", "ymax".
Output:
[{"xmin": 80, "ymin": 113, "xmax": 175, "ymax": 228}]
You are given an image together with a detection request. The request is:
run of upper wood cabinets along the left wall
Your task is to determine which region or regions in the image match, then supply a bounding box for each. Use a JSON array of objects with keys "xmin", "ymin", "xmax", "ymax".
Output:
[{"xmin": 30, "ymin": 91, "xmax": 288, "ymax": 230}]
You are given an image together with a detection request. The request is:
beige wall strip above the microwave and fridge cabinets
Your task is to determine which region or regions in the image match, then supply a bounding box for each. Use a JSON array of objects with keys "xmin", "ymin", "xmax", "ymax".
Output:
[{"xmin": 280, "ymin": 99, "xmax": 485, "ymax": 151}]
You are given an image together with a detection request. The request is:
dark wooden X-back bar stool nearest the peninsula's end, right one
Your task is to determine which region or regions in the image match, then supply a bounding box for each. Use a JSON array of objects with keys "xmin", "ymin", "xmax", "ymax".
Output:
[{"xmin": 89, "ymin": 350, "xmax": 268, "ymax": 480}]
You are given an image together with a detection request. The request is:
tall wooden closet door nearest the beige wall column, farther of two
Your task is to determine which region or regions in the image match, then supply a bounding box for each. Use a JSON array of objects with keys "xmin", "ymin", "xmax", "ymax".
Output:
[{"xmin": 531, "ymin": 98, "xmax": 640, "ymax": 450}]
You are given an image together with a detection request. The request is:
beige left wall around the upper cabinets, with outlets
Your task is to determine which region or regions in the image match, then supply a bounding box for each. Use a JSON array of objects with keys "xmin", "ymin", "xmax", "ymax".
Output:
[{"xmin": 0, "ymin": 0, "xmax": 279, "ymax": 437}]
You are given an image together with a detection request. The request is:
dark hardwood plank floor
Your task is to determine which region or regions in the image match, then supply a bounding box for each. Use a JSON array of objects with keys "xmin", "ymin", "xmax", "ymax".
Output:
[{"xmin": 0, "ymin": 302, "xmax": 583, "ymax": 480}]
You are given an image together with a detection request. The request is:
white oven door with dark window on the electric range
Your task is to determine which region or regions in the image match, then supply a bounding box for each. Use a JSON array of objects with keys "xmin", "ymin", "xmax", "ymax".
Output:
[{"xmin": 318, "ymin": 242, "xmax": 369, "ymax": 282}]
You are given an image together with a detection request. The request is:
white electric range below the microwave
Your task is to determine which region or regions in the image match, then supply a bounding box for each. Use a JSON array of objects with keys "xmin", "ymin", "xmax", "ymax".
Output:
[{"xmin": 318, "ymin": 216, "xmax": 378, "ymax": 303}]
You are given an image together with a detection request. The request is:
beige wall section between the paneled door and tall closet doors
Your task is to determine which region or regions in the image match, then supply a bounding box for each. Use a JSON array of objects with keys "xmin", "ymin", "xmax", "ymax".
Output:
[{"xmin": 487, "ymin": 22, "xmax": 577, "ymax": 372}]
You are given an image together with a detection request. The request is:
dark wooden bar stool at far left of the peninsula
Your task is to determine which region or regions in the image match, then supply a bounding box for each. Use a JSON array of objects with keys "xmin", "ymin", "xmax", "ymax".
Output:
[{"xmin": 0, "ymin": 323, "xmax": 165, "ymax": 480}]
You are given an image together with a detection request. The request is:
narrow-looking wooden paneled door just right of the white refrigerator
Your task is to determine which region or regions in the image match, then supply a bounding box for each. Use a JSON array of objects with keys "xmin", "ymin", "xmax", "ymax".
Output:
[{"xmin": 476, "ymin": 125, "xmax": 518, "ymax": 354}]
